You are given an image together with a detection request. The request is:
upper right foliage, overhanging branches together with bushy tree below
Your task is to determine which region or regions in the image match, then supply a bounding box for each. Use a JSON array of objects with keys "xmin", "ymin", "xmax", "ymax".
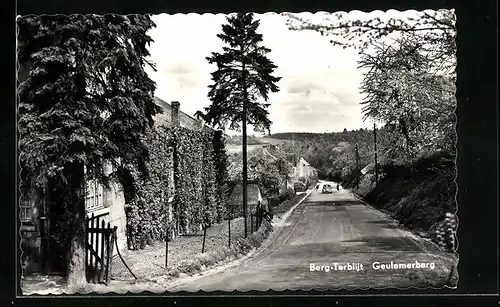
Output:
[{"xmin": 285, "ymin": 10, "xmax": 456, "ymax": 161}]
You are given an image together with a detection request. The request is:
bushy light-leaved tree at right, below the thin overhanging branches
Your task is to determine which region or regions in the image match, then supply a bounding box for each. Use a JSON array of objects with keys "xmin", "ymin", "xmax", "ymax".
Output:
[{"xmin": 360, "ymin": 40, "xmax": 456, "ymax": 157}]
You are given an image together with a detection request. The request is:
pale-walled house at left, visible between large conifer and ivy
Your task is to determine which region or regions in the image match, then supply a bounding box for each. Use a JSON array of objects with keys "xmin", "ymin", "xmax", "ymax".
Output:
[{"xmin": 20, "ymin": 97, "xmax": 211, "ymax": 274}]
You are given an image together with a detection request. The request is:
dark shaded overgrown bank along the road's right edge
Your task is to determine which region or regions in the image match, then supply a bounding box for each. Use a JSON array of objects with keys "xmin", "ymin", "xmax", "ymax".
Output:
[{"xmin": 358, "ymin": 152, "xmax": 457, "ymax": 239}]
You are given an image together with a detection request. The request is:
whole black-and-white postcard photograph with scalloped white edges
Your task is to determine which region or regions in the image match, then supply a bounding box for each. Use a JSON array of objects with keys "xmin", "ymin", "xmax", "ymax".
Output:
[{"xmin": 16, "ymin": 9, "xmax": 459, "ymax": 296}]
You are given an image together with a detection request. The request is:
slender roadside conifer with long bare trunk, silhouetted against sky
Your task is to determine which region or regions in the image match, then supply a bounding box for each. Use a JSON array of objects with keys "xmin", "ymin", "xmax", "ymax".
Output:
[{"xmin": 202, "ymin": 13, "xmax": 281, "ymax": 237}]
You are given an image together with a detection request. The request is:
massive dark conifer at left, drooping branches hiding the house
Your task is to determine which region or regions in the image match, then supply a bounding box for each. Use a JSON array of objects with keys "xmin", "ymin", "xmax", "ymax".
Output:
[{"xmin": 17, "ymin": 15, "xmax": 160, "ymax": 289}]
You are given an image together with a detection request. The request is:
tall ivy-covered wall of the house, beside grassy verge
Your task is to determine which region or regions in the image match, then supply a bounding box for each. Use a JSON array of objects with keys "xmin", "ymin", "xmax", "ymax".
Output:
[{"xmin": 126, "ymin": 126, "xmax": 227, "ymax": 249}]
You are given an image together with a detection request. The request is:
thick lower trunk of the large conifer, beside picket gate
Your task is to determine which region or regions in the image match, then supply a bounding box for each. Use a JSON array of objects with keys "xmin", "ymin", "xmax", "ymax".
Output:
[{"xmin": 68, "ymin": 163, "xmax": 87, "ymax": 291}]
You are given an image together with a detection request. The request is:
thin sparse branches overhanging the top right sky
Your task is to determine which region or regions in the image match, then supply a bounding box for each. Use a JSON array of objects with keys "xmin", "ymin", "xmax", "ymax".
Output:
[{"xmin": 284, "ymin": 9, "xmax": 456, "ymax": 69}]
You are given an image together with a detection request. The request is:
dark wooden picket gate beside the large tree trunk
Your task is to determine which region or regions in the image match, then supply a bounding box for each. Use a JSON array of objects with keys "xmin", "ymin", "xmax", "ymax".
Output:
[{"xmin": 85, "ymin": 214, "xmax": 118, "ymax": 283}]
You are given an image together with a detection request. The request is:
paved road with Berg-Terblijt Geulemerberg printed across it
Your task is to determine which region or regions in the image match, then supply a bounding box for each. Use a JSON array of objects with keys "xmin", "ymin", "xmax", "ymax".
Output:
[{"xmin": 169, "ymin": 185, "xmax": 453, "ymax": 291}]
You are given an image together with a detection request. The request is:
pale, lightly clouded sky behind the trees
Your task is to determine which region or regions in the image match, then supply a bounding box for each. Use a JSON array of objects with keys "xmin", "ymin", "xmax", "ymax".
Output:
[{"xmin": 147, "ymin": 11, "xmax": 434, "ymax": 134}]
